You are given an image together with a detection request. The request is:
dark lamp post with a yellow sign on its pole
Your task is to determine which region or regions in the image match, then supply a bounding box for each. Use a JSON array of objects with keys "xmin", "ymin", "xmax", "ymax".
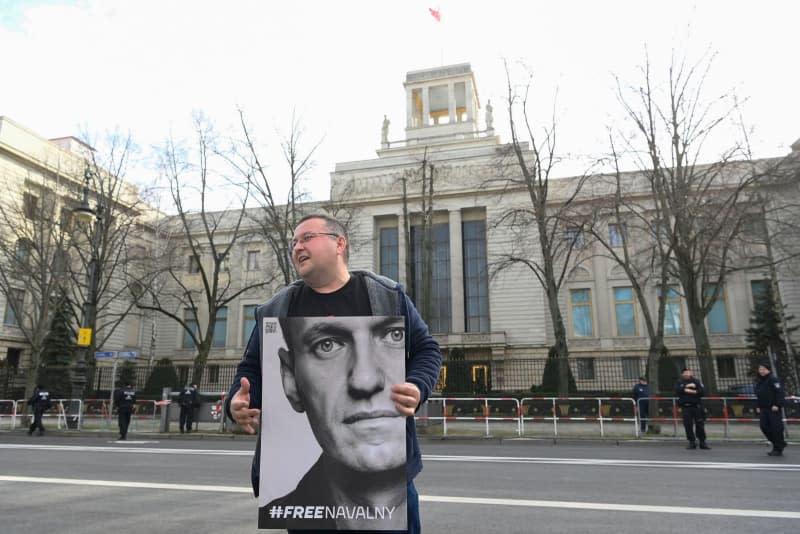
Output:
[{"xmin": 72, "ymin": 163, "xmax": 103, "ymax": 399}]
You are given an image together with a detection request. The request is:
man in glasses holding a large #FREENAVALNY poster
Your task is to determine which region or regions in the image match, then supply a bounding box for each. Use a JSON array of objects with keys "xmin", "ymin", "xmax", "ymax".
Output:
[{"xmin": 226, "ymin": 215, "xmax": 441, "ymax": 533}]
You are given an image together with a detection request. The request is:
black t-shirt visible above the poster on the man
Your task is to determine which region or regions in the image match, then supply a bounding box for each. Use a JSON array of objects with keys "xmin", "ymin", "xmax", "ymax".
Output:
[{"xmin": 288, "ymin": 273, "xmax": 372, "ymax": 317}]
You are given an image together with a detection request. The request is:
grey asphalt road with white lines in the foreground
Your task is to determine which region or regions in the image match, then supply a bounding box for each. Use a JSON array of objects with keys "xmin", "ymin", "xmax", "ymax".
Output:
[{"xmin": 0, "ymin": 432, "xmax": 800, "ymax": 534}]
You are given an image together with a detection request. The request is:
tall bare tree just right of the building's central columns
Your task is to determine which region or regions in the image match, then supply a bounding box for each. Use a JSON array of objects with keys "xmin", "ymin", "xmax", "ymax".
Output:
[{"xmin": 494, "ymin": 63, "xmax": 589, "ymax": 396}]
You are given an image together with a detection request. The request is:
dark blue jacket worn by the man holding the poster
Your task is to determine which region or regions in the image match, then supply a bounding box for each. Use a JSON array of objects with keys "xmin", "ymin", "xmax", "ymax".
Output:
[{"xmin": 225, "ymin": 271, "xmax": 442, "ymax": 496}]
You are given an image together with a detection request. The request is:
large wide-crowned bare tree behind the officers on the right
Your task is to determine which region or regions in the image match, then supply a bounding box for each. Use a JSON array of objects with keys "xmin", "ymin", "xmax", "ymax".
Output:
[{"xmin": 617, "ymin": 49, "xmax": 788, "ymax": 391}]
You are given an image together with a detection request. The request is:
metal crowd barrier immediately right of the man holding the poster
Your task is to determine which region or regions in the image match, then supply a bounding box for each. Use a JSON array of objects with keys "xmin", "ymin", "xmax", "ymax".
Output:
[{"xmin": 416, "ymin": 397, "xmax": 520, "ymax": 437}]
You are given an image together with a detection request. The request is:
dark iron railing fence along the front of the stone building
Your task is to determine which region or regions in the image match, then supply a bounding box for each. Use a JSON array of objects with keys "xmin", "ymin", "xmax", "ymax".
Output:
[{"xmin": 0, "ymin": 354, "xmax": 780, "ymax": 398}]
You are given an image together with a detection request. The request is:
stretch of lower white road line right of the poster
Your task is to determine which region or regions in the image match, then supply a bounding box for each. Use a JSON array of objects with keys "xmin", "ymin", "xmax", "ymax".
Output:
[{"xmin": 419, "ymin": 495, "xmax": 800, "ymax": 519}]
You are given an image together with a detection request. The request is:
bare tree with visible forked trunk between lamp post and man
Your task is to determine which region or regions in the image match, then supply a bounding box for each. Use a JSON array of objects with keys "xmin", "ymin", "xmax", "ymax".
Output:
[{"xmin": 137, "ymin": 116, "xmax": 274, "ymax": 383}]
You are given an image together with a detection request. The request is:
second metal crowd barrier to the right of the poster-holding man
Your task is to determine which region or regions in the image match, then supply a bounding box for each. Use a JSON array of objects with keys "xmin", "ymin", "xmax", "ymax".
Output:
[{"xmin": 520, "ymin": 397, "xmax": 639, "ymax": 437}]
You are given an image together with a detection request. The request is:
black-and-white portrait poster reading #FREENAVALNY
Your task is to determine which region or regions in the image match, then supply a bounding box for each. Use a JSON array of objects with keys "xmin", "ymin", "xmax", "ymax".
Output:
[{"xmin": 258, "ymin": 316, "xmax": 407, "ymax": 530}]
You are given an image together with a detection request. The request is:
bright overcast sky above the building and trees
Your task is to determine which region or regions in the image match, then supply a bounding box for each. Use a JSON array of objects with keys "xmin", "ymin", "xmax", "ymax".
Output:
[{"xmin": 0, "ymin": 0, "xmax": 800, "ymax": 211}]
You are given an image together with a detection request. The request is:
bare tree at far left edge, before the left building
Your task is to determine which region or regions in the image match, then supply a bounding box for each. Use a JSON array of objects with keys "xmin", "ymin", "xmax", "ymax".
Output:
[{"xmin": 0, "ymin": 169, "xmax": 69, "ymax": 397}]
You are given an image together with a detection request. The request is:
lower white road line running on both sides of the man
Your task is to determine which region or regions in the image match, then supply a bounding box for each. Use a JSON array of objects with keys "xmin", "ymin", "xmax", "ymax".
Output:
[{"xmin": 0, "ymin": 475, "xmax": 800, "ymax": 519}]
